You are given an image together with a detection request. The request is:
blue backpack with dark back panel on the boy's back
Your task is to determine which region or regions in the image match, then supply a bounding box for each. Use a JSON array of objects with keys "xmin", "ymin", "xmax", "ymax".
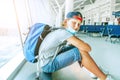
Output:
[{"xmin": 23, "ymin": 23, "xmax": 53, "ymax": 63}]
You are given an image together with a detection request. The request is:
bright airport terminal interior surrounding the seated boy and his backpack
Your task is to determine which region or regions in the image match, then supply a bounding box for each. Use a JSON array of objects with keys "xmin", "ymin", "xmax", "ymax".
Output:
[{"xmin": 0, "ymin": 0, "xmax": 120, "ymax": 80}]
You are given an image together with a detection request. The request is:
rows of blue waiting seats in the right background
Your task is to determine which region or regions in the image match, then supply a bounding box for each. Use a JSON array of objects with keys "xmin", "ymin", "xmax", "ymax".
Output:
[{"xmin": 80, "ymin": 25, "xmax": 120, "ymax": 43}]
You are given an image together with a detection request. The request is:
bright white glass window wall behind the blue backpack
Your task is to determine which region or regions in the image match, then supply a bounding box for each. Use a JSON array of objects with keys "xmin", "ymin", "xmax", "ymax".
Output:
[{"xmin": 0, "ymin": 0, "xmax": 55, "ymax": 68}]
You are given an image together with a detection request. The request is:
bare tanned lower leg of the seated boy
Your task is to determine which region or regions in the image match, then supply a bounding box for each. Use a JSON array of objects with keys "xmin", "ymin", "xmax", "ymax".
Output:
[{"xmin": 79, "ymin": 51, "xmax": 106, "ymax": 80}]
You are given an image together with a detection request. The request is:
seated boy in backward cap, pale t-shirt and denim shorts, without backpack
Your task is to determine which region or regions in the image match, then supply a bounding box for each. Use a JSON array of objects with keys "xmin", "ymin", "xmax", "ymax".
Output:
[{"xmin": 39, "ymin": 12, "xmax": 110, "ymax": 80}]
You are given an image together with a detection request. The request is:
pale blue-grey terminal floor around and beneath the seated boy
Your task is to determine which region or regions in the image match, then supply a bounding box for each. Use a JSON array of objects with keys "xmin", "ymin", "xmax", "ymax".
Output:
[{"xmin": 14, "ymin": 34, "xmax": 120, "ymax": 80}]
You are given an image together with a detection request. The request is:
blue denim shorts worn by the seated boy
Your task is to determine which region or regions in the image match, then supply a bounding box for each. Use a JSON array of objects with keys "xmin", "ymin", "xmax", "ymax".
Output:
[{"xmin": 42, "ymin": 47, "xmax": 81, "ymax": 73}]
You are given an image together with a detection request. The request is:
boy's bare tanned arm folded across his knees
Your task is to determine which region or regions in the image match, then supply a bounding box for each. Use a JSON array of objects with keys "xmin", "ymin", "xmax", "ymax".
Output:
[{"xmin": 67, "ymin": 36, "xmax": 91, "ymax": 52}]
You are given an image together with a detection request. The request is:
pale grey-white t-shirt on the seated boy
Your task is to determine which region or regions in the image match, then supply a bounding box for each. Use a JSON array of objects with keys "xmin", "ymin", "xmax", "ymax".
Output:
[{"xmin": 39, "ymin": 29, "xmax": 73, "ymax": 67}]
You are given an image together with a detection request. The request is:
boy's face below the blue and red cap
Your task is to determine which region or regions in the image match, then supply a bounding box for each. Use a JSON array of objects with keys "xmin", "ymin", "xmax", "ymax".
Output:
[{"xmin": 67, "ymin": 18, "xmax": 81, "ymax": 31}]
